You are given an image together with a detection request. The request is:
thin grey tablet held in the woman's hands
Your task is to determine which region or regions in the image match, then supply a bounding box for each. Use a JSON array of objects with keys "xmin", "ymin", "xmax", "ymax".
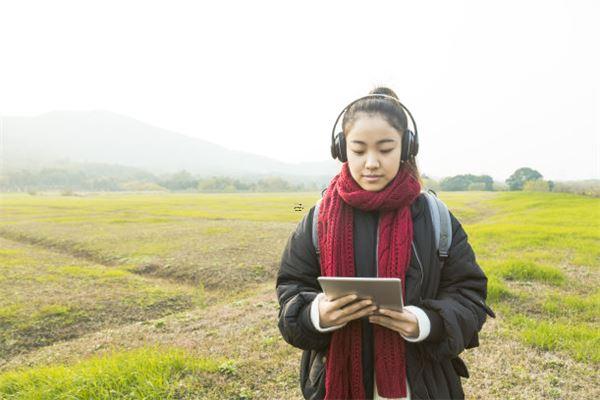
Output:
[{"xmin": 317, "ymin": 276, "xmax": 404, "ymax": 311}]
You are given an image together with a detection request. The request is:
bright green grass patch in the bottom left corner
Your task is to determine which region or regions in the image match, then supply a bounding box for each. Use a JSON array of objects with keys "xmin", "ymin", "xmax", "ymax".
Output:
[{"xmin": 0, "ymin": 347, "xmax": 226, "ymax": 400}]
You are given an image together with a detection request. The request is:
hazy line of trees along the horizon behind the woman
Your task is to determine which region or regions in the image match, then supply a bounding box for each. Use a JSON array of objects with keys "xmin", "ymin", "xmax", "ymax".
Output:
[{"xmin": 0, "ymin": 164, "xmax": 600, "ymax": 197}]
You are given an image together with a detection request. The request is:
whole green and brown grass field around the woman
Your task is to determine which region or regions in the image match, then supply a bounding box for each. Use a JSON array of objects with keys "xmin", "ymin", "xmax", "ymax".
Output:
[{"xmin": 0, "ymin": 192, "xmax": 600, "ymax": 399}]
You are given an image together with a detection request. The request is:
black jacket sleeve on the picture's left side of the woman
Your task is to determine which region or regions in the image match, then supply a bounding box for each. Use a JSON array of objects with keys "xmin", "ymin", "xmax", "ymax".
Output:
[{"xmin": 276, "ymin": 207, "xmax": 331, "ymax": 350}]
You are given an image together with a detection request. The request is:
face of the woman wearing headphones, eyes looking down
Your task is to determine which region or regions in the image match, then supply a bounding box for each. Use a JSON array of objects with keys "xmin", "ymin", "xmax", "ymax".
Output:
[{"xmin": 346, "ymin": 114, "xmax": 402, "ymax": 192}]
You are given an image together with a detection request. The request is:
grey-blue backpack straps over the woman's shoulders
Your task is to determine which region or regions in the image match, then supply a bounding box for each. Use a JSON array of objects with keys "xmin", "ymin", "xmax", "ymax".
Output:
[{"xmin": 312, "ymin": 189, "xmax": 452, "ymax": 266}]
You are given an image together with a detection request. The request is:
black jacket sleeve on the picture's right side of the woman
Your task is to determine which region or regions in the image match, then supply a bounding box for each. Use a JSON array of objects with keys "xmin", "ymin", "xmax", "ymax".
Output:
[{"xmin": 421, "ymin": 213, "xmax": 495, "ymax": 360}]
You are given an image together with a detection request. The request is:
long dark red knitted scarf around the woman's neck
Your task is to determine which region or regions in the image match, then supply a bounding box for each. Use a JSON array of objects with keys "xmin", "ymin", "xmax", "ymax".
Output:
[{"xmin": 318, "ymin": 162, "xmax": 421, "ymax": 399}]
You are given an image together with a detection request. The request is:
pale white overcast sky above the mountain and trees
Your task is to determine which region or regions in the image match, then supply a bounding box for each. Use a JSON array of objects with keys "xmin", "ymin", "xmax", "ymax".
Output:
[{"xmin": 0, "ymin": 0, "xmax": 600, "ymax": 180}]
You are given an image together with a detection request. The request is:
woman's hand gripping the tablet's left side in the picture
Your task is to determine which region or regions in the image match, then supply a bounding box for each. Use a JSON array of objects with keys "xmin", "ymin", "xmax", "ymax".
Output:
[{"xmin": 319, "ymin": 294, "xmax": 377, "ymax": 328}]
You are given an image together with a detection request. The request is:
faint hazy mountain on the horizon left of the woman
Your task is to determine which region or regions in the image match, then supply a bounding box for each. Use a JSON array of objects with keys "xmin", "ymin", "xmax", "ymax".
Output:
[{"xmin": 2, "ymin": 110, "xmax": 339, "ymax": 180}]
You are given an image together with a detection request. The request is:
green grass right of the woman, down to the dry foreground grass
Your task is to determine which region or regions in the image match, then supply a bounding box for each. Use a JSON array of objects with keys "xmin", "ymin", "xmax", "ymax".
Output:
[{"xmin": 440, "ymin": 192, "xmax": 600, "ymax": 363}]
